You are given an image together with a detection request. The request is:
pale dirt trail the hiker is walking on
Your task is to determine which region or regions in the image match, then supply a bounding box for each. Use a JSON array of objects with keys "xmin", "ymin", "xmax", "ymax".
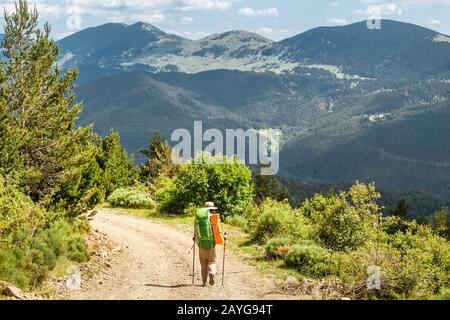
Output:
[{"xmin": 70, "ymin": 211, "xmax": 292, "ymax": 300}]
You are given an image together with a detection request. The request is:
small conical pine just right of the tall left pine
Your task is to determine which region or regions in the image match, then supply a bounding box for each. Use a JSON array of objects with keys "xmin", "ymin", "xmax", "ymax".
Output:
[{"xmin": 97, "ymin": 129, "xmax": 139, "ymax": 196}]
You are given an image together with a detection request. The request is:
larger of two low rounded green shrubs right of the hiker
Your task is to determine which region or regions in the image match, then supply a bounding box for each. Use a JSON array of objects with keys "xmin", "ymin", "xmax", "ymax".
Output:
[{"xmin": 284, "ymin": 244, "xmax": 331, "ymax": 277}]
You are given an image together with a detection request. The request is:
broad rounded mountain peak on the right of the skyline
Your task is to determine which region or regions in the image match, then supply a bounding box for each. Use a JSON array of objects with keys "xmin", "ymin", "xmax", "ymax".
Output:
[{"xmin": 266, "ymin": 20, "xmax": 450, "ymax": 79}]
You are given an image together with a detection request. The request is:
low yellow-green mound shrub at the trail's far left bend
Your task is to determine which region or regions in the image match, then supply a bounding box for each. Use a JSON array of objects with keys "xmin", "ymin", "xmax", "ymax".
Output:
[{"xmin": 108, "ymin": 188, "xmax": 156, "ymax": 209}]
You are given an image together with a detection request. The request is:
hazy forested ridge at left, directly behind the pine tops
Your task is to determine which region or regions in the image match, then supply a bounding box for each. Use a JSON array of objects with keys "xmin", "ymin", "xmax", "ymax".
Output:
[{"xmin": 78, "ymin": 72, "xmax": 250, "ymax": 160}]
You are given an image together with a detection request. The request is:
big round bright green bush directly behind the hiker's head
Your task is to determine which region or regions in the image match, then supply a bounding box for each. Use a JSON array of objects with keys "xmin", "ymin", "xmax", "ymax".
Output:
[{"xmin": 156, "ymin": 153, "xmax": 253, "ymax": 217}]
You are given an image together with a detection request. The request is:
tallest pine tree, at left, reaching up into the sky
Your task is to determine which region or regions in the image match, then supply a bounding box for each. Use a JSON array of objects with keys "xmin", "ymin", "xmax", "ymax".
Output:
[{"xmin": 0, "ymin": 0, "xmax": 97, "ymax": 214}]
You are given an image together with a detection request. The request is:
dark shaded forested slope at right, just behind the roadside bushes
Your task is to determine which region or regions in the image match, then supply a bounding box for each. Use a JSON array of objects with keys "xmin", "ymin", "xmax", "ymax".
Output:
[{"xmin": 282, "ymin": 104, "xmax": 450, "ymax": 197}]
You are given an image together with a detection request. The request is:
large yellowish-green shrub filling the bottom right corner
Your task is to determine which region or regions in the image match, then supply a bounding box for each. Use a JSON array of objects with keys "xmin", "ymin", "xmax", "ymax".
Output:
[{"xmin": 333, "ymin": 222, "xmax": 450, "ymax": 299}]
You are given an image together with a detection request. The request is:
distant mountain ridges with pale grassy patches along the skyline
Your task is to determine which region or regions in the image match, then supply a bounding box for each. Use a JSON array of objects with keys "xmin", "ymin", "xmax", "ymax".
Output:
[{"xmin": 59, "ymin": 20, "xmax": 450, "ymax": 81}]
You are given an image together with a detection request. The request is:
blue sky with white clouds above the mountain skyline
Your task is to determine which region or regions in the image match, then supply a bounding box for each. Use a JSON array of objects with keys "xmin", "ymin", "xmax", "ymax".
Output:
[{"xmin": 0, "ymin": 0, "xmax": 450, "ymax": 40}]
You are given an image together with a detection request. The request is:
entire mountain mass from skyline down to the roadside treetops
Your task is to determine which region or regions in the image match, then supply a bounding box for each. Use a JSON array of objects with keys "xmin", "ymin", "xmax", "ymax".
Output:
[{"xmin": 12, "ymin": 20, "xmax": 450, "ymax": 215}]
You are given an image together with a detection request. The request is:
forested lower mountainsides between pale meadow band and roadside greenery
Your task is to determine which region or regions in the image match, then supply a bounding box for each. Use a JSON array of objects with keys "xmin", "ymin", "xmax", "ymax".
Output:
[{"xmin": 78, "ymin": 70, "xmax": 450, "ymax": 200}]
